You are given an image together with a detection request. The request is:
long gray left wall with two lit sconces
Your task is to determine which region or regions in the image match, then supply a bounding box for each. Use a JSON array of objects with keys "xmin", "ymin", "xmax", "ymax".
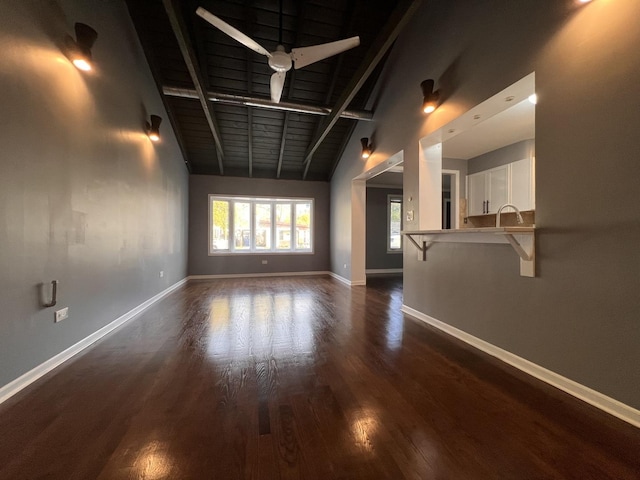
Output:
[{"xmin": 0, "ymin": 0, "xmax": 188, "ymax": 386}]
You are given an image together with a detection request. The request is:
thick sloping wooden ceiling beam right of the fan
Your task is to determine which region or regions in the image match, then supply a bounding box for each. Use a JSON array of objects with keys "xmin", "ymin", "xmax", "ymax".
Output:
[{"xmin": 302, "ymin": 0, "xmax": 422, "ymax": 180}]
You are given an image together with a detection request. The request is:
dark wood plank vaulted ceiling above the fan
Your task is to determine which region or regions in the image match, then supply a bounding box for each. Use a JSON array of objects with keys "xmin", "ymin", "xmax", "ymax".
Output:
[{"xmin": 127, "ymin": 0, "xmax": 415, "ymax": 180}]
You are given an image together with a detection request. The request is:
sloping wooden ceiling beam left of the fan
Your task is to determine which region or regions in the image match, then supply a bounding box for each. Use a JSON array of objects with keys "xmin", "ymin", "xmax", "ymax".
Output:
[{"xmin": 163, "ymin": 0, "xmax": 224, "ymax": 175}]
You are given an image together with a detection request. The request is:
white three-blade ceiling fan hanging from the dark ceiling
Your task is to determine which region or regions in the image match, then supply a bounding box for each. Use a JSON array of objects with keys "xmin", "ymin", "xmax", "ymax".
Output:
[{"xmin": 196, "ymin": 7, "xmax": 360, "ymax": 103}]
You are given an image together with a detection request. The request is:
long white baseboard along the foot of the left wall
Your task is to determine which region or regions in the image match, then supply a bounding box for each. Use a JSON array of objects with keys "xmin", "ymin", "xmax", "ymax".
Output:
[{"xmin": 0, "ymin": 278, "xmax": 187, "ymax": 403}]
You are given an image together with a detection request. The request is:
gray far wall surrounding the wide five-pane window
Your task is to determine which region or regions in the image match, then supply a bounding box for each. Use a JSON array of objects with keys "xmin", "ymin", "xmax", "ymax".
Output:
[{"xmin": 189, "ymin": 175, "xmax": 329, "ymax": 275}]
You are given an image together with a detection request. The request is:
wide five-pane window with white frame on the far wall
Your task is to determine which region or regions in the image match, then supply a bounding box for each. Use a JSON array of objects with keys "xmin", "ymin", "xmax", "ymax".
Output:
[{"xmin": 209, "ymin": 195, "xmax": 313, "ymax": 255}]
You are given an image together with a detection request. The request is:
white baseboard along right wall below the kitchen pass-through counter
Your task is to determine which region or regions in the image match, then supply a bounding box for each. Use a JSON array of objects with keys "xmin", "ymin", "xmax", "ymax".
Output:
[{"xmin": 402, "ymin": 305, "xmax": 640, "ymax": 427}]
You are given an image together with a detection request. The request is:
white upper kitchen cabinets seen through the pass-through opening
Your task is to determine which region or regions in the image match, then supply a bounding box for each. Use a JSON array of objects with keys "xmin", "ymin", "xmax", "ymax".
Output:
[{"xmin": 467, "ymin": 165, "xmax": 511, "ymax": 216}]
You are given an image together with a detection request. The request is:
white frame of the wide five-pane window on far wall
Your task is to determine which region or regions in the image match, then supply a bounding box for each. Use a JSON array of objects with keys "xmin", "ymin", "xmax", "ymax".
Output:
[{"xmin": 208, "ymin": 194, "xmax": 315, "ymax": 256}]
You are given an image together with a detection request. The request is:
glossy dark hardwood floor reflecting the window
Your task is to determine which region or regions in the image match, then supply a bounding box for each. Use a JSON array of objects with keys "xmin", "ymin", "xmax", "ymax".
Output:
[{"xmin": 0, "ymin": 277, "xmax": 640, "ymax": 480}]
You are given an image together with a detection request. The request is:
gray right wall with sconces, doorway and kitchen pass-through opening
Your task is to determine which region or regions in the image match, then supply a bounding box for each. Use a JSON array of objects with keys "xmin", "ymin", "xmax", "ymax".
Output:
[{"xmin": 331, "ymin": 0, "xmax": 640, "ymax": 408}]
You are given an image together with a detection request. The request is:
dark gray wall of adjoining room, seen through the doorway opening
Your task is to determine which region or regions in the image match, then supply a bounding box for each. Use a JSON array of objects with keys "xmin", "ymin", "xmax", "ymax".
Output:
[{"xmin": 366, "ymin": 187, "xmax": 402, "ymax": 270}]
